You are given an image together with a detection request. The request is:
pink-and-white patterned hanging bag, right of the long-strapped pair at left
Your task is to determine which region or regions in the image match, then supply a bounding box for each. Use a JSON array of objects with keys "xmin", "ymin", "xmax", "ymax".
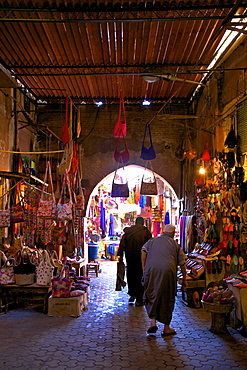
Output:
[{"xmin": 56, "ymin": 170, "xmax": 72, "ymax": 221}]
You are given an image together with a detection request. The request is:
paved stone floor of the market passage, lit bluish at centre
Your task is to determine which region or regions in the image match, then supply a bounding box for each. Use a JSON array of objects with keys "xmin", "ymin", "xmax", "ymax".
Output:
[{"xmin": 0, "ymin": 261, "xmax": 247, "ymax": 370}]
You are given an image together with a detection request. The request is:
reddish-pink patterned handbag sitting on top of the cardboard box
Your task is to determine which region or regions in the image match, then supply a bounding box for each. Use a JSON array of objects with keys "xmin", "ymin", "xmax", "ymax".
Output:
[{"xmin": 51, "ymin": 265, "xmax": 73, "ymax": 298}]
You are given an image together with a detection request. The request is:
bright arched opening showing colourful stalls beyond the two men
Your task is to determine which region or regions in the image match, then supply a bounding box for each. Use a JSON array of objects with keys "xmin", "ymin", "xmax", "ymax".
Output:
[{"xmin": 86, "ymin": 165, "xmax": 179, "ymax": 259}]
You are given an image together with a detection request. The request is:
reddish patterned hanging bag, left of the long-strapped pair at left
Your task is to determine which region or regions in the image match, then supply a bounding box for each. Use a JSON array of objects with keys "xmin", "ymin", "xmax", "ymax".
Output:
[{"xmin": 37, "ymin": 161, "xmax": 56, "ymax": 219}]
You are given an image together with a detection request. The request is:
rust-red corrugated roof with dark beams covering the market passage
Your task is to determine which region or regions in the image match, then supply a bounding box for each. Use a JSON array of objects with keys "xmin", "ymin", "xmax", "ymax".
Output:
[{"xmin": 0, "ymin": 0, "xmax": 247, "ymax": 103}]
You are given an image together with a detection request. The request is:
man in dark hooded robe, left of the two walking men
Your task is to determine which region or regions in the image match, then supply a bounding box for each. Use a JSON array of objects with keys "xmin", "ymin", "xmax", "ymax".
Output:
[{"xmin": 118, "ymin": 216, "xmax": 152, "ymax": 306}]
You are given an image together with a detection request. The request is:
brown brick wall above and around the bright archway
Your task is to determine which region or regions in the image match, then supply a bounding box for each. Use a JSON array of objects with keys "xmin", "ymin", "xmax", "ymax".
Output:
[{"xmin": 39, "ymin": 105, "xmax": 188, "ymax": 205}]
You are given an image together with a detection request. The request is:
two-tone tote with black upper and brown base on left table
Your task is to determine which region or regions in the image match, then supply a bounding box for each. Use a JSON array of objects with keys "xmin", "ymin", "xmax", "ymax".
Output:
[{"xmin": 14, "ymin": 248, "xmax": 36, "ymax": 285}]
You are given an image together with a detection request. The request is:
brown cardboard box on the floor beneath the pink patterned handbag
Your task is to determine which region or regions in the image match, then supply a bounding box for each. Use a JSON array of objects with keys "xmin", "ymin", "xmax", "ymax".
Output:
[{"xmin": 48, "ymin": 294, "xmax": 86, "ymax": 317}]
